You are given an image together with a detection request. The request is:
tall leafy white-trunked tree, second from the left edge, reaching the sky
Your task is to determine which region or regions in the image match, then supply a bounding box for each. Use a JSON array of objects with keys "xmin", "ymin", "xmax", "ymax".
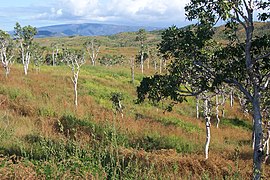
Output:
[{"xmin": 14, "ymin": 22, "xmax": 37, "ymax": 75}]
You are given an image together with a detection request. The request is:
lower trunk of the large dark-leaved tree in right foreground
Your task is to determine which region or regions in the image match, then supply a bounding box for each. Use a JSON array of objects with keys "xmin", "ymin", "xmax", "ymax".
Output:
[{"xmin": 252, "ymin": 95, "xmax": 263, "ymax": 179}]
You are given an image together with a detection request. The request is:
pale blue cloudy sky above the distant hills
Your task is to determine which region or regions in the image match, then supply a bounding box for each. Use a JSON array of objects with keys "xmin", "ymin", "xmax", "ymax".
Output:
[{"xmin": 0, "ymin": 0, "xmax": 189, "ymax": 31}]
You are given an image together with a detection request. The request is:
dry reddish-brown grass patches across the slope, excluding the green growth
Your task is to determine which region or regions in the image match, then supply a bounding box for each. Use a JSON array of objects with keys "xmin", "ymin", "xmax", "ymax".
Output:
[{"xmin": 0, "ymin": 65, "xmax": 270, "ymax": 179}]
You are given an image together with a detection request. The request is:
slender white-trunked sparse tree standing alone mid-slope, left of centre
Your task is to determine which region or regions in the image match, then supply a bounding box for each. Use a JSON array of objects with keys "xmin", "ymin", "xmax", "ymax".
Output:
[{"xmin": 64, "ymin": 49, "xmax": 85, "ymax": 108}]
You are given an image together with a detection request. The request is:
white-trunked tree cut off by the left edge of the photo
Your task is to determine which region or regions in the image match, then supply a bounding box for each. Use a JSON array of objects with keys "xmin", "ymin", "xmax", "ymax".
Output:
[{"xmin": 0, "ymin": 30, "xmax": 14, "ymax": 77}]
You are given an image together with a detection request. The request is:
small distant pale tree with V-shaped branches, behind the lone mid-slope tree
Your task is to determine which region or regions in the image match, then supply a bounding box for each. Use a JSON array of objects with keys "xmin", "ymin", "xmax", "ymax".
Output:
[{"xmin": 85, "ymin": 39, "xmax": 100, "ymax": 66}]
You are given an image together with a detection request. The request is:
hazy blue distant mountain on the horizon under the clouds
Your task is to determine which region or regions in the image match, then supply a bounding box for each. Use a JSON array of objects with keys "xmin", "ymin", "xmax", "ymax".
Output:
[{"xmin": 36, "ymin": 23, "xmax": 162, "ymax": 37}]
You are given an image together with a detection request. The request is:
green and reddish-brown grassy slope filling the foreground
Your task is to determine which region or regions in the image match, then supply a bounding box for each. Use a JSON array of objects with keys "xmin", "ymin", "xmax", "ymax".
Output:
[{"xmin": 0, "ymin": 62, "xmax": 270, "ymax": 179}]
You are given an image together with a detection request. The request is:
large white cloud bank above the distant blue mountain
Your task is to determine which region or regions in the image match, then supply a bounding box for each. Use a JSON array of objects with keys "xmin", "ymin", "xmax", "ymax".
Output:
[{"xmin": 32, "ymin": 0, "xmax": 189, "ymax": 26}]
